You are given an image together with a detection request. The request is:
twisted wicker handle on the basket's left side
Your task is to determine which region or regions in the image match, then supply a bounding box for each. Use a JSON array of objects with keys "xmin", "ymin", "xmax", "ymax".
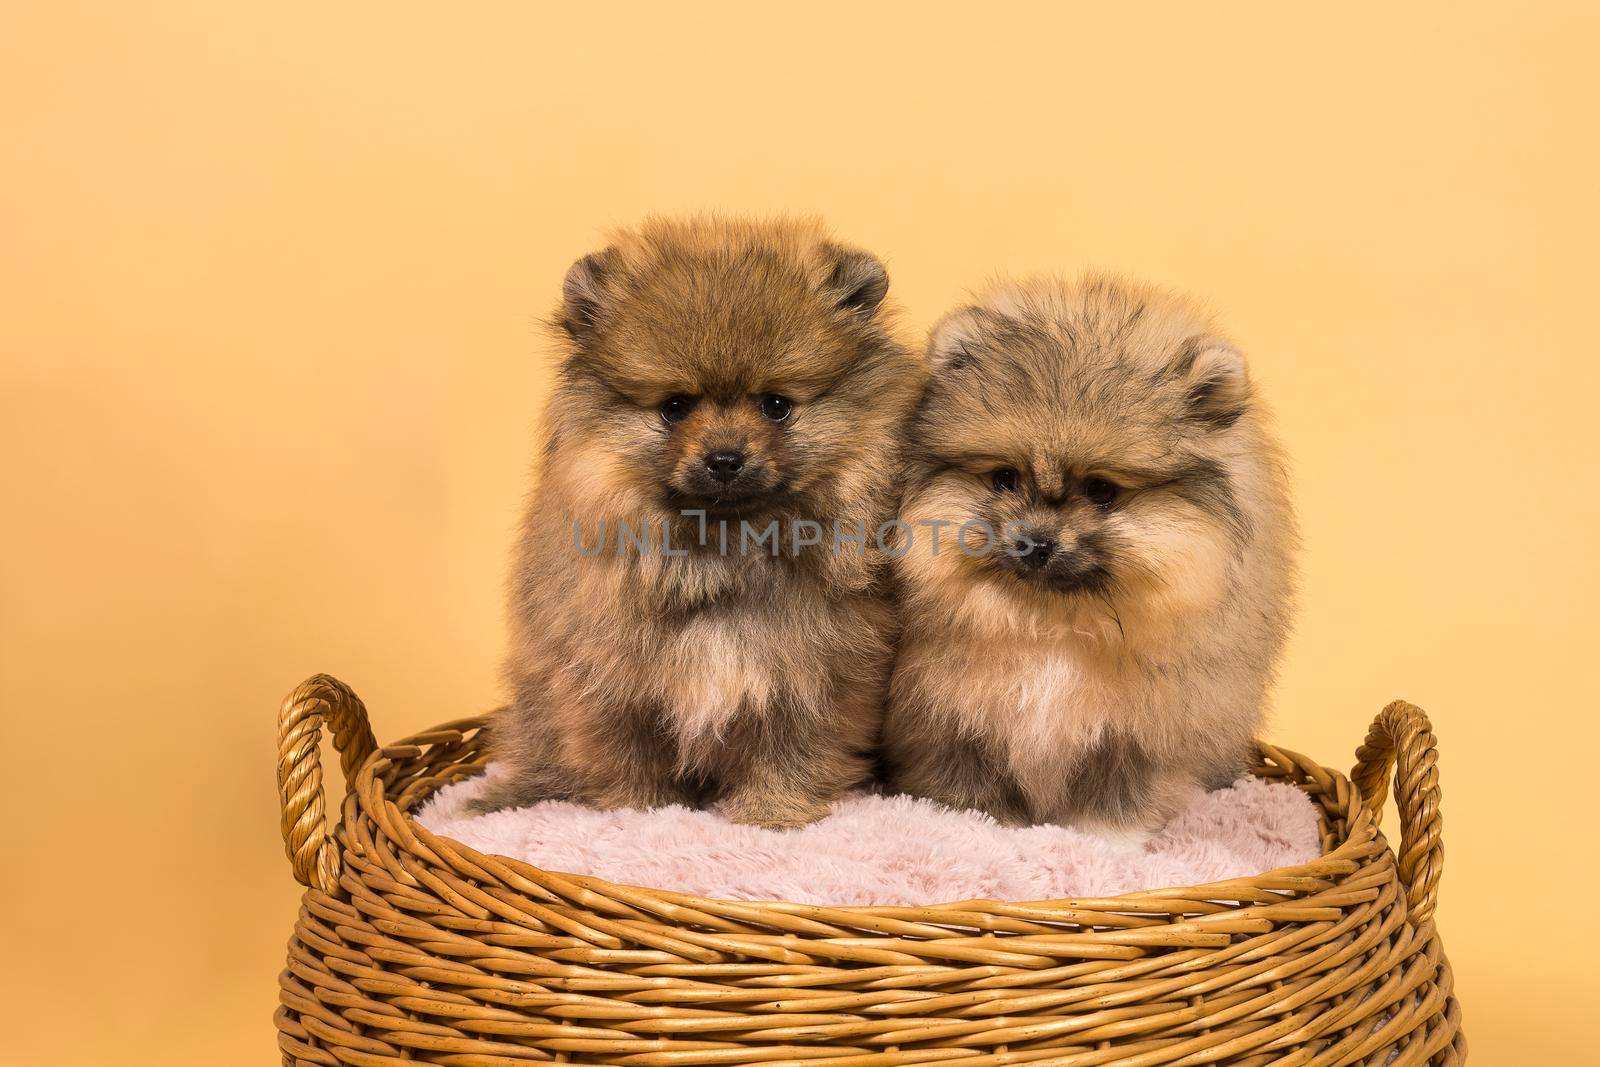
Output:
[{"xmin": 278, "ymin": 675, "xmax": 378, "ymax": 893}]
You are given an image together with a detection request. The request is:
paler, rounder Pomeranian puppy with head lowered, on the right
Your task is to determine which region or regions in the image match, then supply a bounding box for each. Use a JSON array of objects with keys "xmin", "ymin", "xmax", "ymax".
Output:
[{"xmin": 883, "ymin": 278, "xmax": 1296, "ymax": 841}]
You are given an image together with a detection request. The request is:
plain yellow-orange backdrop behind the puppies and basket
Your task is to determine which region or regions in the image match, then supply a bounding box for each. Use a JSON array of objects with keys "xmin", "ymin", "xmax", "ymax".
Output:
[{"xmin": 0, "ymin": 2, "xmax": 1600, "ymax": 1064}]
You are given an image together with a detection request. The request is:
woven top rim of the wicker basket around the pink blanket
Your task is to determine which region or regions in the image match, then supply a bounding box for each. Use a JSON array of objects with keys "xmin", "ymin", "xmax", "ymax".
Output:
[{"xmin": 339, "ymin": 715, "xmax": 1389, "ymax": 918}]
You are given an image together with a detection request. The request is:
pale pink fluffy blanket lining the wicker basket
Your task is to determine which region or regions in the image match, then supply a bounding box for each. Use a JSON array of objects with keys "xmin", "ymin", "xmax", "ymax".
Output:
[{"xmin": 416, "ymin": 769, "xmax": 1322, "ymax": 907}]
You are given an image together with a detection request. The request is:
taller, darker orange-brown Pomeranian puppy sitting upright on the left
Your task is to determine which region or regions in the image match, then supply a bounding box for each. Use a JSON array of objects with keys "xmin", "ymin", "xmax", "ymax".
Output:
[{"xmin": 478, "ymin": 219, "xmax": 922, "ymax": 827}]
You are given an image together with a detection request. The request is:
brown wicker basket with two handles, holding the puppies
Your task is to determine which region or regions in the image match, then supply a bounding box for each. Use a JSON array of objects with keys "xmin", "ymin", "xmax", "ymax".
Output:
[{"xmin": 277, "ymin": 675, "xmax": 1466, "ymax": 1067}]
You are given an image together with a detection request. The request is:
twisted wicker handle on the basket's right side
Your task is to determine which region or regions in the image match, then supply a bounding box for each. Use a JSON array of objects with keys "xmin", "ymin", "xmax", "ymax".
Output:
[{"xmin": 1350, "ymin": 701, "xmax": 1445, "ymax": 925}]
